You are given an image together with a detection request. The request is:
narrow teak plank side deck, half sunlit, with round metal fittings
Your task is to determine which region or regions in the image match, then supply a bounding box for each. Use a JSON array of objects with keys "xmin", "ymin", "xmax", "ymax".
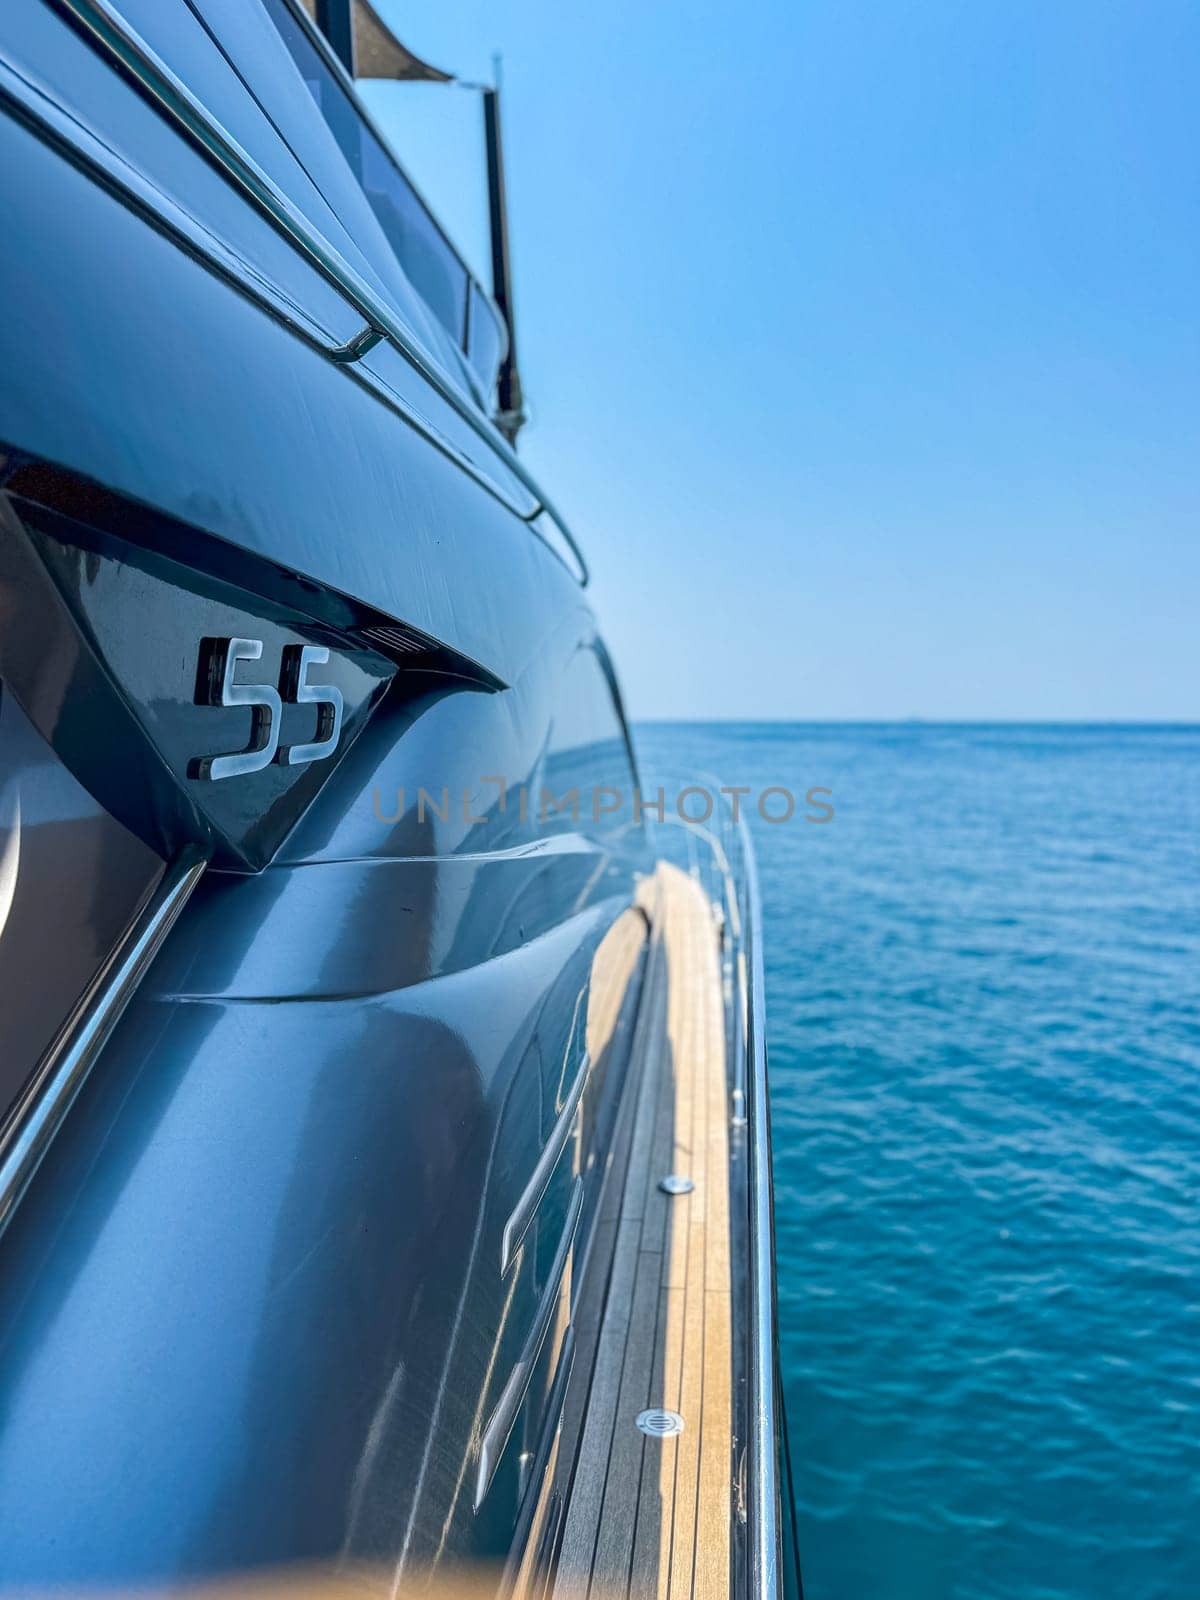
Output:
[{"xmin": 557, "ymin": 864, "xmax": 733, "ymax": 1600}]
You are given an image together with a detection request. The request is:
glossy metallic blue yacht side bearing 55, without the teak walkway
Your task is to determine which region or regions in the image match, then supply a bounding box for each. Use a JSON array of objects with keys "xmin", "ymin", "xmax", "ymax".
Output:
[{"xmin": 0, "ymin": 0, "xmax": 646, "ymax": 1589}]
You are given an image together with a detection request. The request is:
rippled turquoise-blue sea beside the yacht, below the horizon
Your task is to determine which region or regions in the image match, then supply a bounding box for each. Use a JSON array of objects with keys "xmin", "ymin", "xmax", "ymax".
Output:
[{"xmin": 637, "ymin": 723, "xmax": 1200, "ymax": 1600}]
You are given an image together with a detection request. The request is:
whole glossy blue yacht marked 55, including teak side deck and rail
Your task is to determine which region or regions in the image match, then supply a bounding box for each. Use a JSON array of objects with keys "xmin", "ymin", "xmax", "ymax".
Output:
[{"xmin": 0, "ymin": 0, "xmax": 797, "ymax": 1600}]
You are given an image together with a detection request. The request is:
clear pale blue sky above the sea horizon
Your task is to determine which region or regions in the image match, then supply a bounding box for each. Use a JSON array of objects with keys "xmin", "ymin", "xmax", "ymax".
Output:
[{"xmin": 366, "ymin": 0, "xmax": 1200, "ymax": 720}]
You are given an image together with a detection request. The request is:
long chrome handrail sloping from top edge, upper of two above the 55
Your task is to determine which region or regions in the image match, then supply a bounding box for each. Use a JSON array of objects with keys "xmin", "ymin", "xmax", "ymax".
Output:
[{"xmin": 54, "ymin": 0, "xmax": 586, "ymax": 585}]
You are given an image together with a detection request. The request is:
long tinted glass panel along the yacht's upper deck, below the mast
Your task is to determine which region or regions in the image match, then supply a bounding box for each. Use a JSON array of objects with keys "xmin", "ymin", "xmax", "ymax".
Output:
[{"xmin": 266, "ymin": 0, "xmax": 467, "ymax": 346}]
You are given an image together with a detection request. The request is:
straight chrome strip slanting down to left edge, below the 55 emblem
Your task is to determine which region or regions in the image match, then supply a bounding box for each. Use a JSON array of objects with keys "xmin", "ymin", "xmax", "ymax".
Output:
[{"xmin": 0, "ymin": 850, "xmax": 208, "ymax": 1232}]
